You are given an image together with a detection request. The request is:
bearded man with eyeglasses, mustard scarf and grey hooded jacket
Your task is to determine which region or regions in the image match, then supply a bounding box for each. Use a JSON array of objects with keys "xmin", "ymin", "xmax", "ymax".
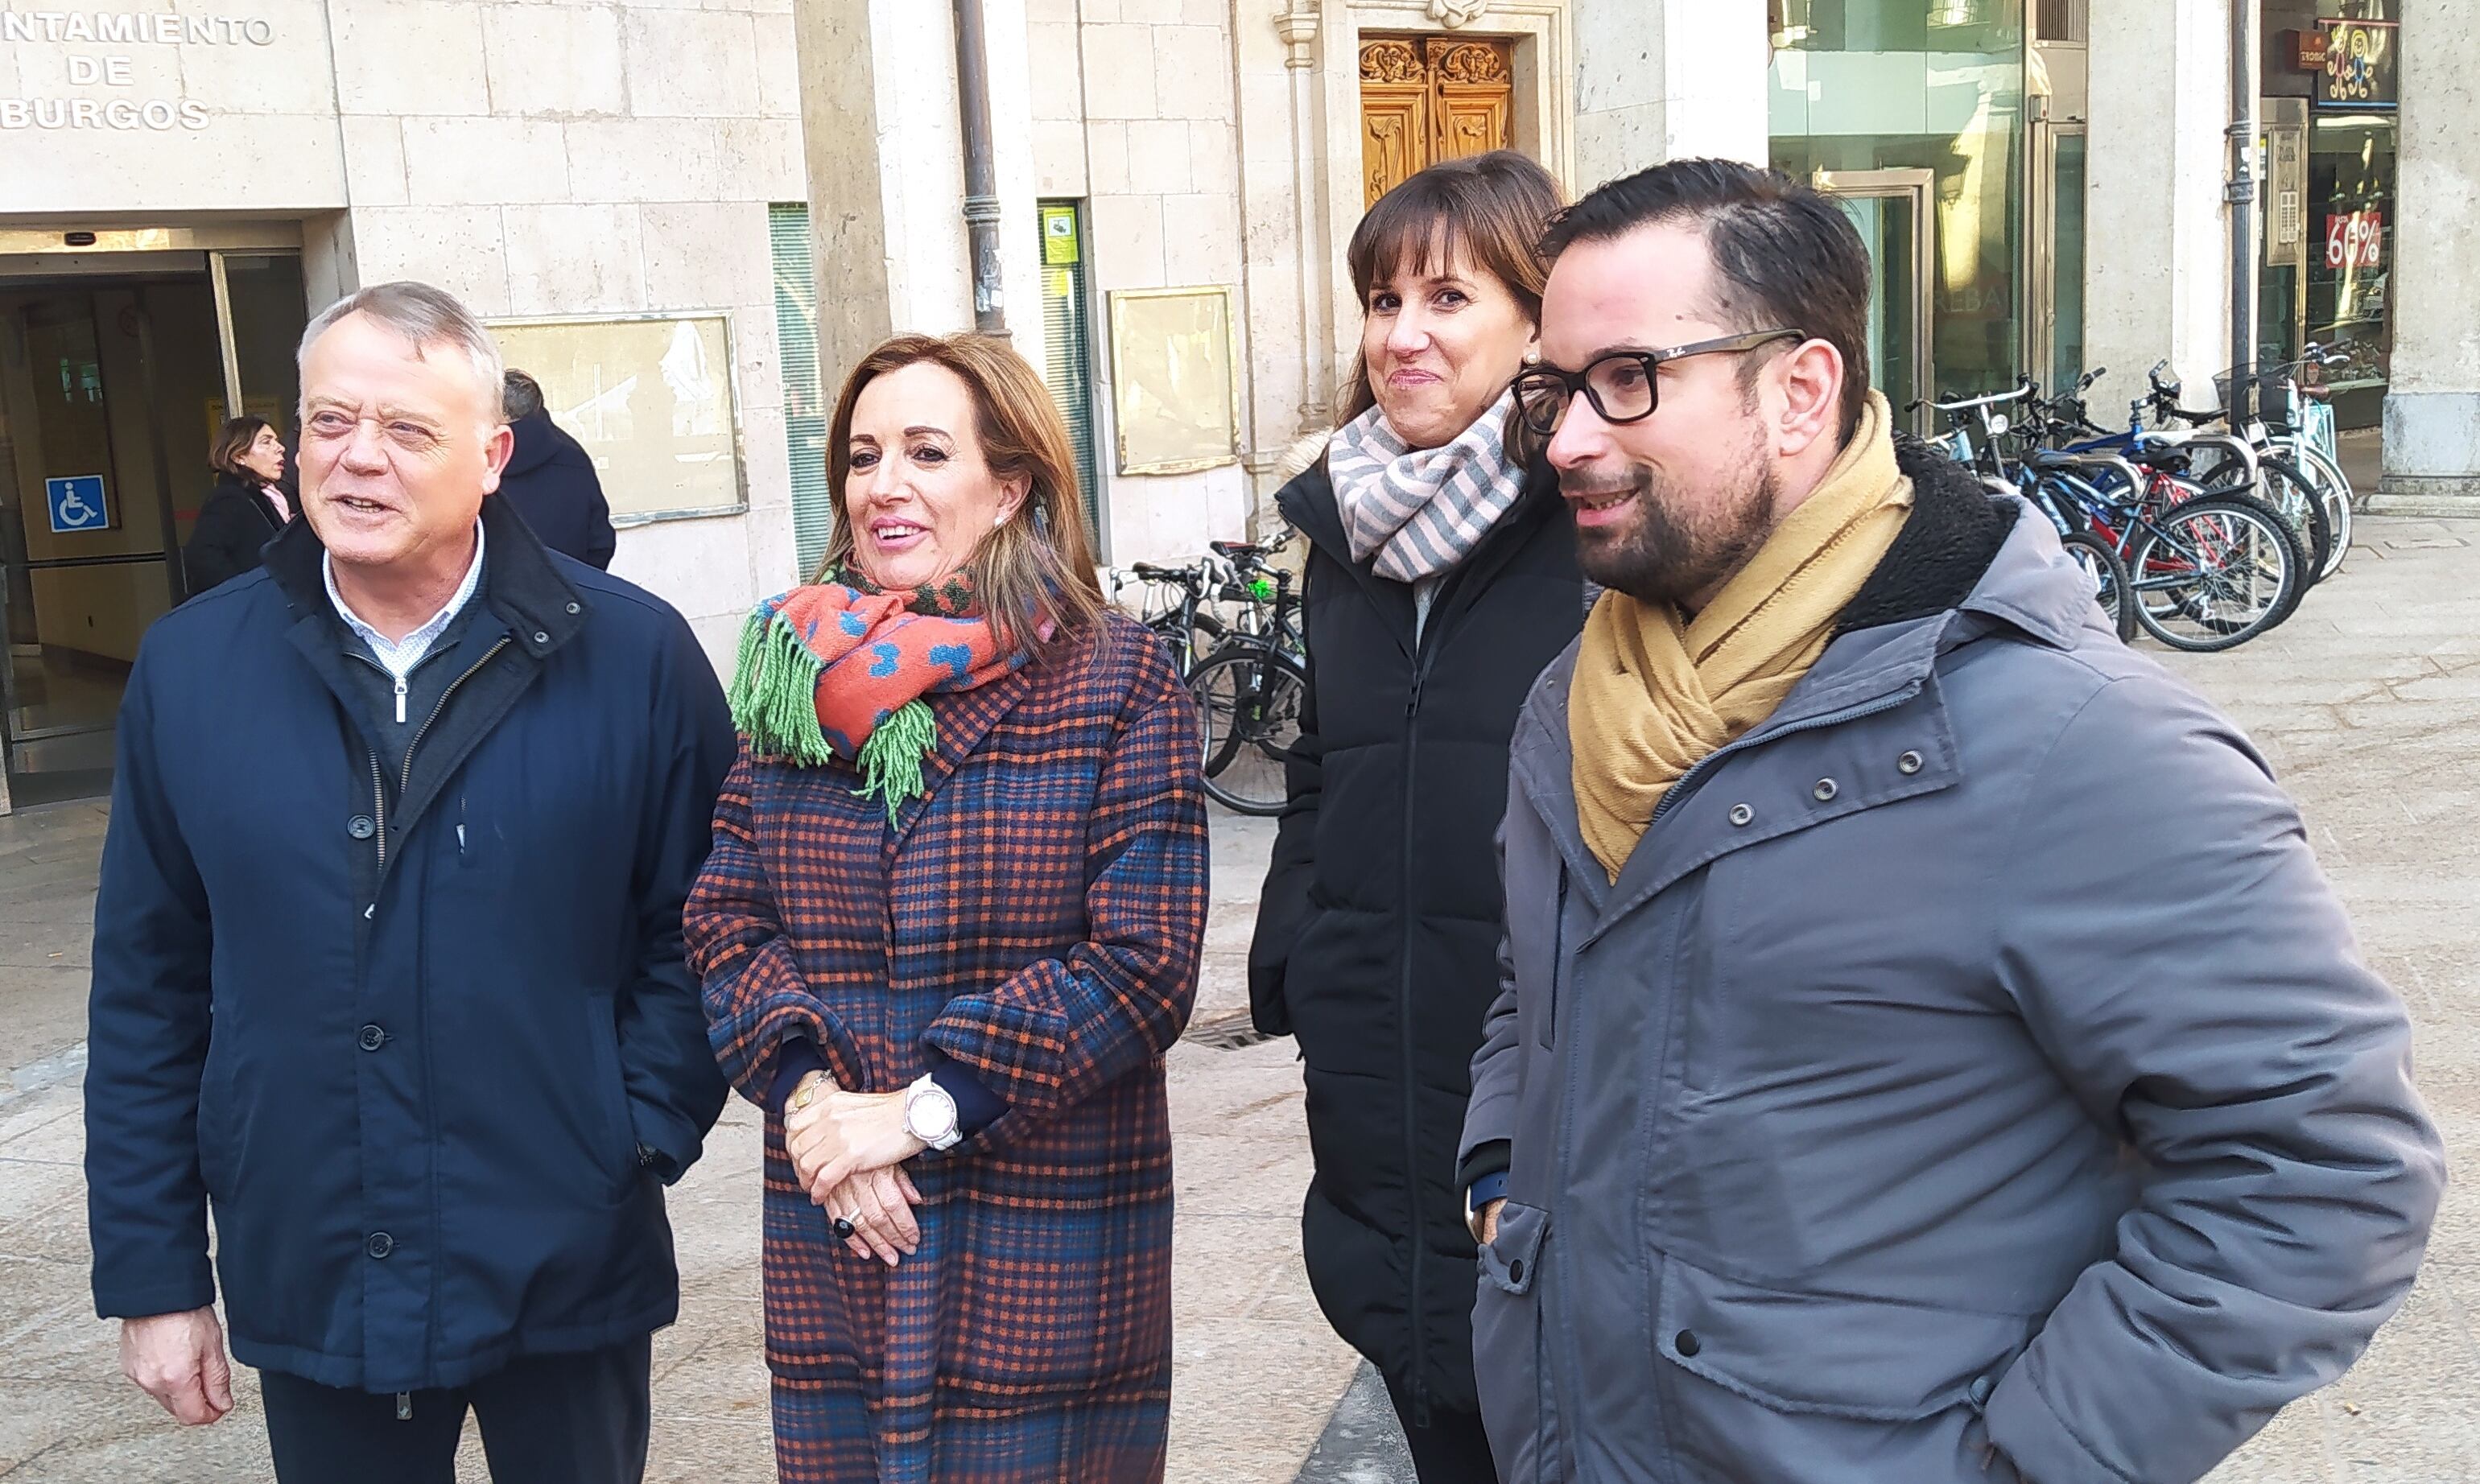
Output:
[{"xmin": 1459, "ymin": 161, "xmax": 2443, "ymax": 1484}]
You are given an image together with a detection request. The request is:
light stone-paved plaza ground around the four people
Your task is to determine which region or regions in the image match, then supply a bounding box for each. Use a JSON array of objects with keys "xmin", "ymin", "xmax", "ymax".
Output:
[{"xmin": 0, "ymin": 508, "xmax": 2480, "ymax": 1484}]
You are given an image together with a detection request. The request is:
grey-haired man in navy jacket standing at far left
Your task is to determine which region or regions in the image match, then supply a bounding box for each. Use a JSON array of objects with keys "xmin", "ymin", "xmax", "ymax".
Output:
[{"xmin": 87, "ymin": 285, "xmax": 734, "ymax": 1484}]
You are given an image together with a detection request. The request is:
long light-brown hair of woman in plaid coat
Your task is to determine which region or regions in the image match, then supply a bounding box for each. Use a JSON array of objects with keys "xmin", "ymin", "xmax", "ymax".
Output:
[{"xmin": 811, "ymin": 335, "xmax": 1104, "ymax": 649}]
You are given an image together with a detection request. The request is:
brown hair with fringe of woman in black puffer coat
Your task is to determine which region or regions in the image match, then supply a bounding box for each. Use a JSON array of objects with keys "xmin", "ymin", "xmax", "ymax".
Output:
[{"xmin": 1342, "ymin": 149, "xmax": 1565, "ymax": 421}]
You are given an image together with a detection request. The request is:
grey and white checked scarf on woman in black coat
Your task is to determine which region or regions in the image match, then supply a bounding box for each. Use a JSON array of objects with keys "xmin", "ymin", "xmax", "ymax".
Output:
[{"xmin": 1327, "ymin": 391, "xmax": 1525, "ymax": 582}]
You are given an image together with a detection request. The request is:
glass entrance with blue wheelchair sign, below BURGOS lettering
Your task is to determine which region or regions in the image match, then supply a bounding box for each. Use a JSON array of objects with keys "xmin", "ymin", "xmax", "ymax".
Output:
[{"xmin": 0, "ymin": 235, "xmax": 307, "ymax": 813}]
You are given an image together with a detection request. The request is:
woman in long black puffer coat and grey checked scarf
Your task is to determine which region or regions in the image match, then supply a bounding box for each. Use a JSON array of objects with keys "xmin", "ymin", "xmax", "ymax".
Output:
[{"xmin": 1250, "ymin": 151, "xmax": 1585, "ymax": 1484}]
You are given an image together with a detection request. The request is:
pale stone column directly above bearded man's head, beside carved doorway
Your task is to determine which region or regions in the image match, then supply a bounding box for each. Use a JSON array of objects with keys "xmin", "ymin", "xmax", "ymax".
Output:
[{"xmin": 1572, "ymin": 0, "xmax": 1768, "ymax": 193}]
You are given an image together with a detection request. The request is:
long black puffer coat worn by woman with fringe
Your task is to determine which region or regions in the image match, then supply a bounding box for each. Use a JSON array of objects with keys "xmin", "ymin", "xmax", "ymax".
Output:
[{"xmin": 1250, "ymin": 464, "xmax": 1585, "ymax": 1412}]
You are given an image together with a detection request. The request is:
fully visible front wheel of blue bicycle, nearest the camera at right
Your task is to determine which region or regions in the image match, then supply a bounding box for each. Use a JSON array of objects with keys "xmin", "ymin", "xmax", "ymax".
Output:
[{"xmin": 2127, "ymin": 496, "xmax": 2306, "ymax": 654}]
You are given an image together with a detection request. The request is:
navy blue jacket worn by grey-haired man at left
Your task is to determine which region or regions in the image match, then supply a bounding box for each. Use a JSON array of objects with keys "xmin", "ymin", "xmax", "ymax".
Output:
[{"xmin": 87, "ymin": 498, "xmax": 734, "ymax": 1392}]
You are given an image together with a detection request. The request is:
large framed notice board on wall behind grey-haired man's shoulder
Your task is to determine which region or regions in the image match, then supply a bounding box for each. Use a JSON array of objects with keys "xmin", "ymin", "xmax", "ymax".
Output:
[{"xmin": 491, "ymin": 312, "xmax": 749, "ymax": 526}]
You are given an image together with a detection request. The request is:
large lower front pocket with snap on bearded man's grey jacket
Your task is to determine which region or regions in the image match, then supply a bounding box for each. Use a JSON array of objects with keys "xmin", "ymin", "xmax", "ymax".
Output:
[{"xmin": 1654, "ymin": 1259, "xmax": 2039, "ymax": 1422}]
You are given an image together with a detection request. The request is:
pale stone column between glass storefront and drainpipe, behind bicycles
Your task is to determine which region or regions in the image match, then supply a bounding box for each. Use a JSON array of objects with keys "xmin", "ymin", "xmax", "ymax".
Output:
[{"xmin": 2083, "ymin": 0, "xmax": 2230, "ymax": 423}]
